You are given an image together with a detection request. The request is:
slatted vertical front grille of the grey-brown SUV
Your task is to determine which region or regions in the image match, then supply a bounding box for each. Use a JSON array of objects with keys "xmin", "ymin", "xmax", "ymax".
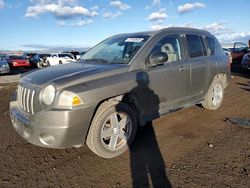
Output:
[{"xmin": 17, "ymin": 85, "xmax": 35, "ymax": 114}]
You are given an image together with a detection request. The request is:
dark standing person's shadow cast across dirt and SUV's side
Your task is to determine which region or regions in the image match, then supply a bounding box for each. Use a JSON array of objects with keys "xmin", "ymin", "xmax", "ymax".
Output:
[{"xmin": 122, "ymin": 72, "xmax": 172, "ymax": 188}]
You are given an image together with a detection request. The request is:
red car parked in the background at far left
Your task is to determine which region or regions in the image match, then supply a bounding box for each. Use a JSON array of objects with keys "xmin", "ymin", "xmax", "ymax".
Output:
[{"xmin": 7, "ymin": 55, "xmax": 31, "ymax": 68}]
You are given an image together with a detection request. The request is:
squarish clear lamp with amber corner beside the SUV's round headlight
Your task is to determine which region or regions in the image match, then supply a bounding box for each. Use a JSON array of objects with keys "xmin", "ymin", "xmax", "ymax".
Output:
[{"xmin": 58, "ymin": 91, "xmax": 83, "ymax": 107}]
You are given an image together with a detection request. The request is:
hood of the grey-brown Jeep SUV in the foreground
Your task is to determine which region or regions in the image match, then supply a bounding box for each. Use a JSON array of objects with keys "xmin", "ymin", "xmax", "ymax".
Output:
[{"xmin": 20, "ymin": 62, "xmax": 128, "ymax": 89}]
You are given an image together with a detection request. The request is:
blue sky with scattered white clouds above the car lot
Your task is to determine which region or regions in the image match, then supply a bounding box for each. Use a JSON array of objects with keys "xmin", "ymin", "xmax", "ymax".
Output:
[{"xmin": 0, "ymin": 0, "xmax": 250, "ymax": 50}]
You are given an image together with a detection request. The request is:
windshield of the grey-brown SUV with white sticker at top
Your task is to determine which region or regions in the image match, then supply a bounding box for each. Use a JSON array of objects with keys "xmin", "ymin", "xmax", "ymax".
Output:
[{"xmin": 81, "ymin": 35, "xmax": 149, "ymax": 64}]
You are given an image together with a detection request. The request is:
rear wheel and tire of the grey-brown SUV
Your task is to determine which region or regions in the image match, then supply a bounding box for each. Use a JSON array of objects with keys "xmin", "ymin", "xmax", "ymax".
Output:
[{"xmin": 202, "ymin": 77, "xmax": 224, "ymax": 110}]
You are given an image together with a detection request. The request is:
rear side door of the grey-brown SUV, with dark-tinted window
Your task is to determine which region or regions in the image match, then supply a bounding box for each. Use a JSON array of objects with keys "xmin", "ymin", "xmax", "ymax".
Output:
[{"xmin": 186, "ymin": 34, "xmax": 216, "ymax": 102}]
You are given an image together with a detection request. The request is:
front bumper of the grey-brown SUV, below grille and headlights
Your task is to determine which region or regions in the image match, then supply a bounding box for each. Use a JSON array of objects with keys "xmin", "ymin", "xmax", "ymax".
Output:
[{"xmin": 10, "ymin": 101, "xmax": 94, "ymax": 148}]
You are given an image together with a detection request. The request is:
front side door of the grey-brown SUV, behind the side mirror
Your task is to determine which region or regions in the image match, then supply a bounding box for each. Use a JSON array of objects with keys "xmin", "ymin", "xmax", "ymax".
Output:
[{"xmin": 147, "ymin": 34, "xmax": 190, "ymax": 113}]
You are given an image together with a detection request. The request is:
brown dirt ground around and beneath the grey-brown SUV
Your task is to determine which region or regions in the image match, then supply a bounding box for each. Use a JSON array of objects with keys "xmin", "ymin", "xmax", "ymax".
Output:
[{"xmin": 0, "ymin": 65, "xmax": 250, "ymax": 188}]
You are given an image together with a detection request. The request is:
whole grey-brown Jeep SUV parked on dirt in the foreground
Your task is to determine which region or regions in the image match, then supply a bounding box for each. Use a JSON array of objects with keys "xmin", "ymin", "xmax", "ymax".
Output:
[{"xmin": 10, "ymin": 28, "xmax": 230, "ymax": 158}]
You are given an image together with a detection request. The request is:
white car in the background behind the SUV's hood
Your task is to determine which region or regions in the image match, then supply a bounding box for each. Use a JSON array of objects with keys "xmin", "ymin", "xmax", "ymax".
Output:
[{"xmin": 46, "ymin": 53, "xmax": 76, "ymax": 66}]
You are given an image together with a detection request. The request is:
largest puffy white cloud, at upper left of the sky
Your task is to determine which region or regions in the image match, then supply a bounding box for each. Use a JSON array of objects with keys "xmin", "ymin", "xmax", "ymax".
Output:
[{"xmin": 25, "ymin": 0, "xmax": 98, "ymax": 19}]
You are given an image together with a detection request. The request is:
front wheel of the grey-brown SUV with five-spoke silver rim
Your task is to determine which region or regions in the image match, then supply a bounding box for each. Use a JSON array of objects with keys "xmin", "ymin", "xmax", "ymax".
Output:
[{"xmin": 87, "ymin": 101, "xmax": 137, "ymax": 158}]
